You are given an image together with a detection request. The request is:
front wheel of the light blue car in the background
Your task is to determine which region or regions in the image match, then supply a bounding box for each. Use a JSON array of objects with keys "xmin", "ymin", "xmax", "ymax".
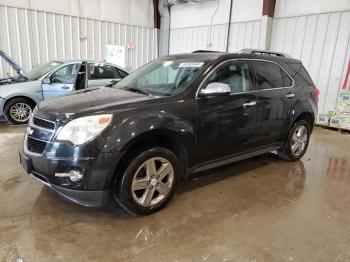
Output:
[{"xmin": 4, "ymin": 97, "xmax": 35, "ymax": 125}]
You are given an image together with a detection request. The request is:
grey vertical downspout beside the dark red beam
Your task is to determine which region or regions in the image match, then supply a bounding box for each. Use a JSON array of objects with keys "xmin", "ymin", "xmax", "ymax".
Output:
[{"xmin": 158, "ymin": 0, "xmax": 170, "ymax": 57}]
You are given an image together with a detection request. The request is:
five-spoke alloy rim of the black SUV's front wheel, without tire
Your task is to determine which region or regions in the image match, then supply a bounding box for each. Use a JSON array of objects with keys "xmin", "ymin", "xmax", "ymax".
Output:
[{"xmin": 131, "ymin": 157, "xmax": 174, "ymax": 207}]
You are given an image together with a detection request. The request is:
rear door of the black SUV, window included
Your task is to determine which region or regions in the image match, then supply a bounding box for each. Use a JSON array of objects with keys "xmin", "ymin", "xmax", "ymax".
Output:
[{"xmin": 250, "ymin": 60, "xmax": 296, "ymax": 147}]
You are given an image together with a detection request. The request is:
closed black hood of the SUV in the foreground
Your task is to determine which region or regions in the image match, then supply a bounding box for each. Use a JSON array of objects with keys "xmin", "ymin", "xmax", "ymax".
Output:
[{"xmin": 35, "ymin": 87, "xmax": 159, "ymax": 121}]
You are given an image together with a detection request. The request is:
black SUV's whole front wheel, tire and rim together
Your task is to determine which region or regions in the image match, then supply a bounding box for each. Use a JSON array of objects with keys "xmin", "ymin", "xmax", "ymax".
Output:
[{"xmin": 114, "ymin": 147, "xmax": 179, "ymax": 215}]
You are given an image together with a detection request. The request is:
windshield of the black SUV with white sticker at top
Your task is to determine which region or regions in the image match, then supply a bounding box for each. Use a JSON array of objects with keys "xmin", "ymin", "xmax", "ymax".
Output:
[{"xmin": 116, "ymin": 58, "xmax": 208, "ymax": 96}]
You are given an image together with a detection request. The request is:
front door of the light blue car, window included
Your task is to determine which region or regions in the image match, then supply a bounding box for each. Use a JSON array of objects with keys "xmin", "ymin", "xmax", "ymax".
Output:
[{"xmin": 42, "ymin": 63, "xmax": 81, "ymax": 100}]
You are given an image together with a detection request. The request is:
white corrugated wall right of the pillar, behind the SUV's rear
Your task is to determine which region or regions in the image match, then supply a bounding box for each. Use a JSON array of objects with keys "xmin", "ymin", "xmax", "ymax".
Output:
[{"xmin": 270, "ymin": 0, "xmax": 350, "ymax": 112}]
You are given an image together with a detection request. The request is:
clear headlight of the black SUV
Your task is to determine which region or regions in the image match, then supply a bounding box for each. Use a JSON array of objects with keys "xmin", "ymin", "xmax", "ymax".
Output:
[{"xmin": 56, "ymin": 114, "xmax": 112, "ymax": 145}]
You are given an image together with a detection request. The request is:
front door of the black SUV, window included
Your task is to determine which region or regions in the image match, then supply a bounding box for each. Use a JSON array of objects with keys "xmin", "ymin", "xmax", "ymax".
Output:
[{"xmin": 197, "ymin": 60, "xmax": 257, "ymax": 162}]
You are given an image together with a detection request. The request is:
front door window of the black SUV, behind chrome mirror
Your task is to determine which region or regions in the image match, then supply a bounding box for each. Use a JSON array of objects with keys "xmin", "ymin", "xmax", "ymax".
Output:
[{"xmin": 205, "ymin": 61, "xmax": 252, "ymax": 93}]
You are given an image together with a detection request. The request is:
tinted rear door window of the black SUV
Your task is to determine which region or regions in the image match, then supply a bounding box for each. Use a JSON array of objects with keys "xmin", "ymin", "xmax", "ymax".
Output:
[{"xmin": 253, "ymin": 61, "xmax": 293, "ymax": 89}]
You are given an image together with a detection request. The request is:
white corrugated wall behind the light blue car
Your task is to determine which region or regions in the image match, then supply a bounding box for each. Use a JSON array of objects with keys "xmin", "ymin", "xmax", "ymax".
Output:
[{"xmin": 0, "ymin": 0, "xmax": 158, "ymax": 77}]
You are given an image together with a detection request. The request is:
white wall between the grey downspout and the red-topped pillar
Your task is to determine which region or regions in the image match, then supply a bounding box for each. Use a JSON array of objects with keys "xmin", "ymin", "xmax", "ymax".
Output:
[{"xmin": 169, "ymin": 0, "xmax": 263, "ymax": 54}]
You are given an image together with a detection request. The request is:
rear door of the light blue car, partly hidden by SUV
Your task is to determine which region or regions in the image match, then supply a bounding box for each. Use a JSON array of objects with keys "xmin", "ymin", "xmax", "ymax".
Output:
[{"xmin": 88, "ymin": 63, "xmax": 122, "ymax": 87}]
